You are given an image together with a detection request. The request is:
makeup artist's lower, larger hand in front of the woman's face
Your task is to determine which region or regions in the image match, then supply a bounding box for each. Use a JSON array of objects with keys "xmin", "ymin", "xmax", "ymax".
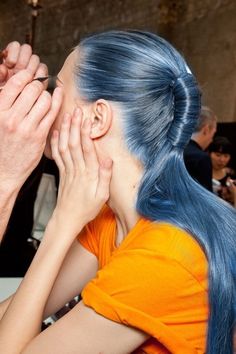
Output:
[{"xmin": 0, "ymin": 69, "xmax": 62, "ymax": 194}]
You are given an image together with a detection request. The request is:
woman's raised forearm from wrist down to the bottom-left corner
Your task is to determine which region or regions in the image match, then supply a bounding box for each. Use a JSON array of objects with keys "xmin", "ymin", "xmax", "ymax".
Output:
[{"xmin": 0, "ymin": 214, "xmax": 84, "ymax": 354}]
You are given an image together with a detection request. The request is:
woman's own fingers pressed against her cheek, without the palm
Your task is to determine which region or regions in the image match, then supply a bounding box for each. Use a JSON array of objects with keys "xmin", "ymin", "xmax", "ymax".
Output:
[{"xmin": 51, "ymin": 109, "xmax": 112, "ymax": 191}]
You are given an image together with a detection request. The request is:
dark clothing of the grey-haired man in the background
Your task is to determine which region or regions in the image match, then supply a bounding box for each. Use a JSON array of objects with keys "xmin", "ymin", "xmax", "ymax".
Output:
[{"xmin": 184, "ymin": 140, "xmax": 212, "ymax": 192}]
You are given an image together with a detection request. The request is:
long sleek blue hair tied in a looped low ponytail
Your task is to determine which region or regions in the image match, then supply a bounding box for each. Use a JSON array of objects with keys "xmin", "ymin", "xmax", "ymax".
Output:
[{"xmin": 75, "ymin": 31, "xmax": 236, "ymax": 354}]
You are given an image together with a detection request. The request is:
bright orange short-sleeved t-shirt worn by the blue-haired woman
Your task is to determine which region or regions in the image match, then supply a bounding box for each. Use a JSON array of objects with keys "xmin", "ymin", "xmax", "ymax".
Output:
[{"xmin": 79, "ymin": 208, "xmax": 208, "ymax": 354}]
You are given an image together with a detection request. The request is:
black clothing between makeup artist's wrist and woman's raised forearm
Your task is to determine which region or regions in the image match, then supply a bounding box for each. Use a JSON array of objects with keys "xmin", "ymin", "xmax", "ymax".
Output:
[{"xmin": 0, "ymin": 159, "xmax": 44, "ymax": 277}]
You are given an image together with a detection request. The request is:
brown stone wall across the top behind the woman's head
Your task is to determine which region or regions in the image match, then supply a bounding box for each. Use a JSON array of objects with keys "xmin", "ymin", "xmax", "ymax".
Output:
[{"xmin": 0, "ymin": 0, "xmax": 236, "ymax": 122}]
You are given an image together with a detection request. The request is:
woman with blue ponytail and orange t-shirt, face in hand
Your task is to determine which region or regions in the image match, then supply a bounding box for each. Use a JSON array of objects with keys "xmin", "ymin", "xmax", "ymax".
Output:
[{"xmin": 0, "ymin": 31, "xmax": 236, "ymax": 354}]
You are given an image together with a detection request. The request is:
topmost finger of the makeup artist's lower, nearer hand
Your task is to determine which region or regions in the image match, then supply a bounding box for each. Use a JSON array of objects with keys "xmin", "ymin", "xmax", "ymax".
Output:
[{"xmin": 0, "ymin": 70, "xmax": 32, "ymax": 110}]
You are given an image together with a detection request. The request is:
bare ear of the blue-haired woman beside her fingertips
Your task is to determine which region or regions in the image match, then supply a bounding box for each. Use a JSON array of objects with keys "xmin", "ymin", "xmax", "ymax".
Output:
[{"xmin": 90, "ymin": 99, "xmax": 112, "ymax": 139}]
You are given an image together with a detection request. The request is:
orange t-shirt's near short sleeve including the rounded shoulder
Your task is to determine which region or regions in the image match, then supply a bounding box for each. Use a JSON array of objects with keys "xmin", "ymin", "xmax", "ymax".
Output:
[{"xmin": 82, "ymin": 249, "xmax": 207, "ymax": 354}]
